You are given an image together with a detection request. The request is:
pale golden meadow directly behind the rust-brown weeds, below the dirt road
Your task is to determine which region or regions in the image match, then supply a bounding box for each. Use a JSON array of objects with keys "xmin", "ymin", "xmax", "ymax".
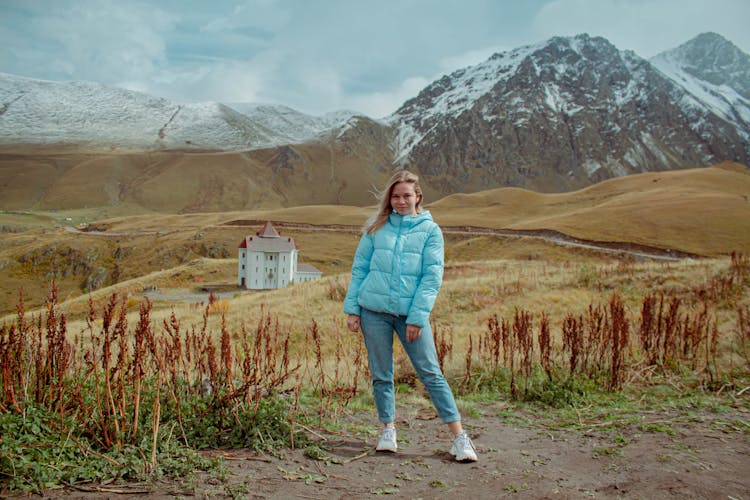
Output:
[{"xmin": 11, "ymin": 244, "xmax": 750, "ymax": 384}]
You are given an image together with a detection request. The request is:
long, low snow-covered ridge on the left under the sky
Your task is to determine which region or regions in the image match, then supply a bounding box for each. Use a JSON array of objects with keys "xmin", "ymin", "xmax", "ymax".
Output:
[{"xmin": 0, "ymin": 73, "xmax": 355, "ymax": 151}]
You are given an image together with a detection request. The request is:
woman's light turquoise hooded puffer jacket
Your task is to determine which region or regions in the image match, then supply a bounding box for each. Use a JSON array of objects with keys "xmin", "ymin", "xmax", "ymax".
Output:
[{"xmin": 344, "ymin": 210, "xmax": 444, "ymax": 327}]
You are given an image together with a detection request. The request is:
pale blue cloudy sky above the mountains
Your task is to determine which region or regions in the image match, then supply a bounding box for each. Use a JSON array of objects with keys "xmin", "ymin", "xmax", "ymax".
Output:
[{"xmin": 0, "ymin": 0, "xmax": 750, "ymax": 118}]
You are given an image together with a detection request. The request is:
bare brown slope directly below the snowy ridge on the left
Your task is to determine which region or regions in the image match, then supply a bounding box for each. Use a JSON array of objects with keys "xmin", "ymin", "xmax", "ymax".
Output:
[{"xmin": 0, "ymin": 135, "xmax": 391, "ymax": 214}]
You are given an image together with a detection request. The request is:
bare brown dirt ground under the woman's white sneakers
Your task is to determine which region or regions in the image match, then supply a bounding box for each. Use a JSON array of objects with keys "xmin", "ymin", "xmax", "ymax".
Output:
[{"xmin": 49, "ymin": 404, "xmax": 750, "ymax": 499}]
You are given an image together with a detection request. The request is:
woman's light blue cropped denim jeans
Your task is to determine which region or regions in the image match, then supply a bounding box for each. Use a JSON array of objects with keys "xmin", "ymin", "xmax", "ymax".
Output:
[{"xmin": 360, "ymin": 309, "xmax": 461, "ymax": 424}]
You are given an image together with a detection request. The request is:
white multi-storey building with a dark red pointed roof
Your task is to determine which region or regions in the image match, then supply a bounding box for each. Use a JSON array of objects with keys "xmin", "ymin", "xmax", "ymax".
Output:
[{"xmin": 237, "ymin": 222, "xmax": 322, "ymax": 290}]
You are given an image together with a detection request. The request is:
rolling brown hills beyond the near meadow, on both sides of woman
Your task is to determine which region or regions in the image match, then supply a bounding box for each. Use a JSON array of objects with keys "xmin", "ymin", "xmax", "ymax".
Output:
[{"xmin": 0, "ymin": 164, "xmax": 750, "ymax": 312}]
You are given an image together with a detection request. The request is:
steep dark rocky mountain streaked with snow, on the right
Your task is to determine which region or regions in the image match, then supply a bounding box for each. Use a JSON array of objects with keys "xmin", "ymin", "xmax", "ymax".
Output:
[{"xmin": 388, "ymin": 34, "xmax": 750, "ymax": 191}]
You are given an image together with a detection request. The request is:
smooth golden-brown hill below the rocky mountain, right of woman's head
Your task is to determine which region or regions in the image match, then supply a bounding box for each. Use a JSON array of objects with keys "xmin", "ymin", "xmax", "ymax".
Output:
[{"xmin": 431, "ymin": 163, "xmax": 750, "ymax": 255}]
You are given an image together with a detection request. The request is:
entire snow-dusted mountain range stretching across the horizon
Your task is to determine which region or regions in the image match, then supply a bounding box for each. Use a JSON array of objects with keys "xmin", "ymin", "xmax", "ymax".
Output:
[{"xmin": 0, "ymin": 33, "xmax": 750, "ymax": 205}]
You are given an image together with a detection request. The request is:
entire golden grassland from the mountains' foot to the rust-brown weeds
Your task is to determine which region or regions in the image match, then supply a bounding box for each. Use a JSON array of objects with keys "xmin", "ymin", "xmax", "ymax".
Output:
[{"xmin": 0, "ymin": 164, "xmax": 750, "ymax": 384}]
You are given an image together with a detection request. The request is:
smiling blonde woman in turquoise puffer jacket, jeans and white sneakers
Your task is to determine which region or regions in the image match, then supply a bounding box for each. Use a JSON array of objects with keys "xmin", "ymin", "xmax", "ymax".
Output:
[{"xmin": 344, "ymin": 170, "xmax": 477, "ymax": 462}]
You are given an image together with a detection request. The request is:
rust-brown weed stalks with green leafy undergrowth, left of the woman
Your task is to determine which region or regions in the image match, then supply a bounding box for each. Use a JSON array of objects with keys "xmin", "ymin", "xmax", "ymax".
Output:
[{"xmin": 0, "ymin": 283, "xmax": 324, "ymax": 491}]
